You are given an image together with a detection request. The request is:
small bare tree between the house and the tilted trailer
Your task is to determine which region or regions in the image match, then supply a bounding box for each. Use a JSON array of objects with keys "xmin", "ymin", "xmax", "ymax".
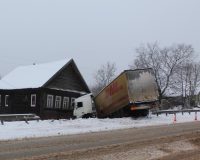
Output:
[{"xmin": 91, "ymin": 62, "xmax": 117, "ymax": 95}]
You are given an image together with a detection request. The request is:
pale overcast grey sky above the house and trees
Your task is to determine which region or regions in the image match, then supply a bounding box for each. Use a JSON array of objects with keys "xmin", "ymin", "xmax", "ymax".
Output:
[{"xmin": 0, "ymin": 0, "xmax": 200, "ymax": 84}]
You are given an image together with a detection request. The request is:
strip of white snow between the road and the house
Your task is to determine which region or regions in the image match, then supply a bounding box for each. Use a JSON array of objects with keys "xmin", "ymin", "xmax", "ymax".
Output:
[{"xmin": 0, "ymin": 113, "xmax": 200, "ymax": 140}]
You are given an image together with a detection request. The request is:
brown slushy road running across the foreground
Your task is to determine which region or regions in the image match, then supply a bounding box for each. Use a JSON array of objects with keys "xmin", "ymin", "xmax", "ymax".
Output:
[{"xmin": 0, "ymin": 122, "xmax": 200, "ymax": 160}]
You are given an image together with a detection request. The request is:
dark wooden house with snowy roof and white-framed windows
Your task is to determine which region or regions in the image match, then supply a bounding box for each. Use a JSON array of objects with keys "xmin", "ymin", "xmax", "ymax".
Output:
[{"xmin": 0, "ymin": 59, "xmax": 90, "ymax": 119}]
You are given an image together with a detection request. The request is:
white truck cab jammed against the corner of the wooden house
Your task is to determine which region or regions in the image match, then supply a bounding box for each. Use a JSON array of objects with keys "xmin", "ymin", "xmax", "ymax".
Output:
[{"xmin": 73, "ymin": 93, "xmax": 96, "ymax": 118}]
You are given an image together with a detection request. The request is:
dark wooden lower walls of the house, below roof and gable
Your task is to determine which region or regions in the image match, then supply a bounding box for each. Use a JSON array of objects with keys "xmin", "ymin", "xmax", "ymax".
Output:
[{"xmin": 0, "ymin": 88, "xmax": 81, "ymax": 119}]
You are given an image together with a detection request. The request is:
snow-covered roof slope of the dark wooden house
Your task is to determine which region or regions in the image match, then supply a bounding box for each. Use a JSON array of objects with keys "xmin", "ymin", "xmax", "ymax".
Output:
[{"xmin": 0, "ymin": 59, "xmax": 71, "ymax": 89}]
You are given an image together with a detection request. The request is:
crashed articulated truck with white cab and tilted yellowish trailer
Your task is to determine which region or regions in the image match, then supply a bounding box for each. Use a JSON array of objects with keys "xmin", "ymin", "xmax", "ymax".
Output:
[{"xmin": 74, "ymin": 68, "xmax": 159, "ymax": 118}]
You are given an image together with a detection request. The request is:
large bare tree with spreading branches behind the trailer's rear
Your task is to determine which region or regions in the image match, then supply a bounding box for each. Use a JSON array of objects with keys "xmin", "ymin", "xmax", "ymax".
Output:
[{"xmin": 131, "ymin": 43, "xmax": 194, "ymax": 101}]
